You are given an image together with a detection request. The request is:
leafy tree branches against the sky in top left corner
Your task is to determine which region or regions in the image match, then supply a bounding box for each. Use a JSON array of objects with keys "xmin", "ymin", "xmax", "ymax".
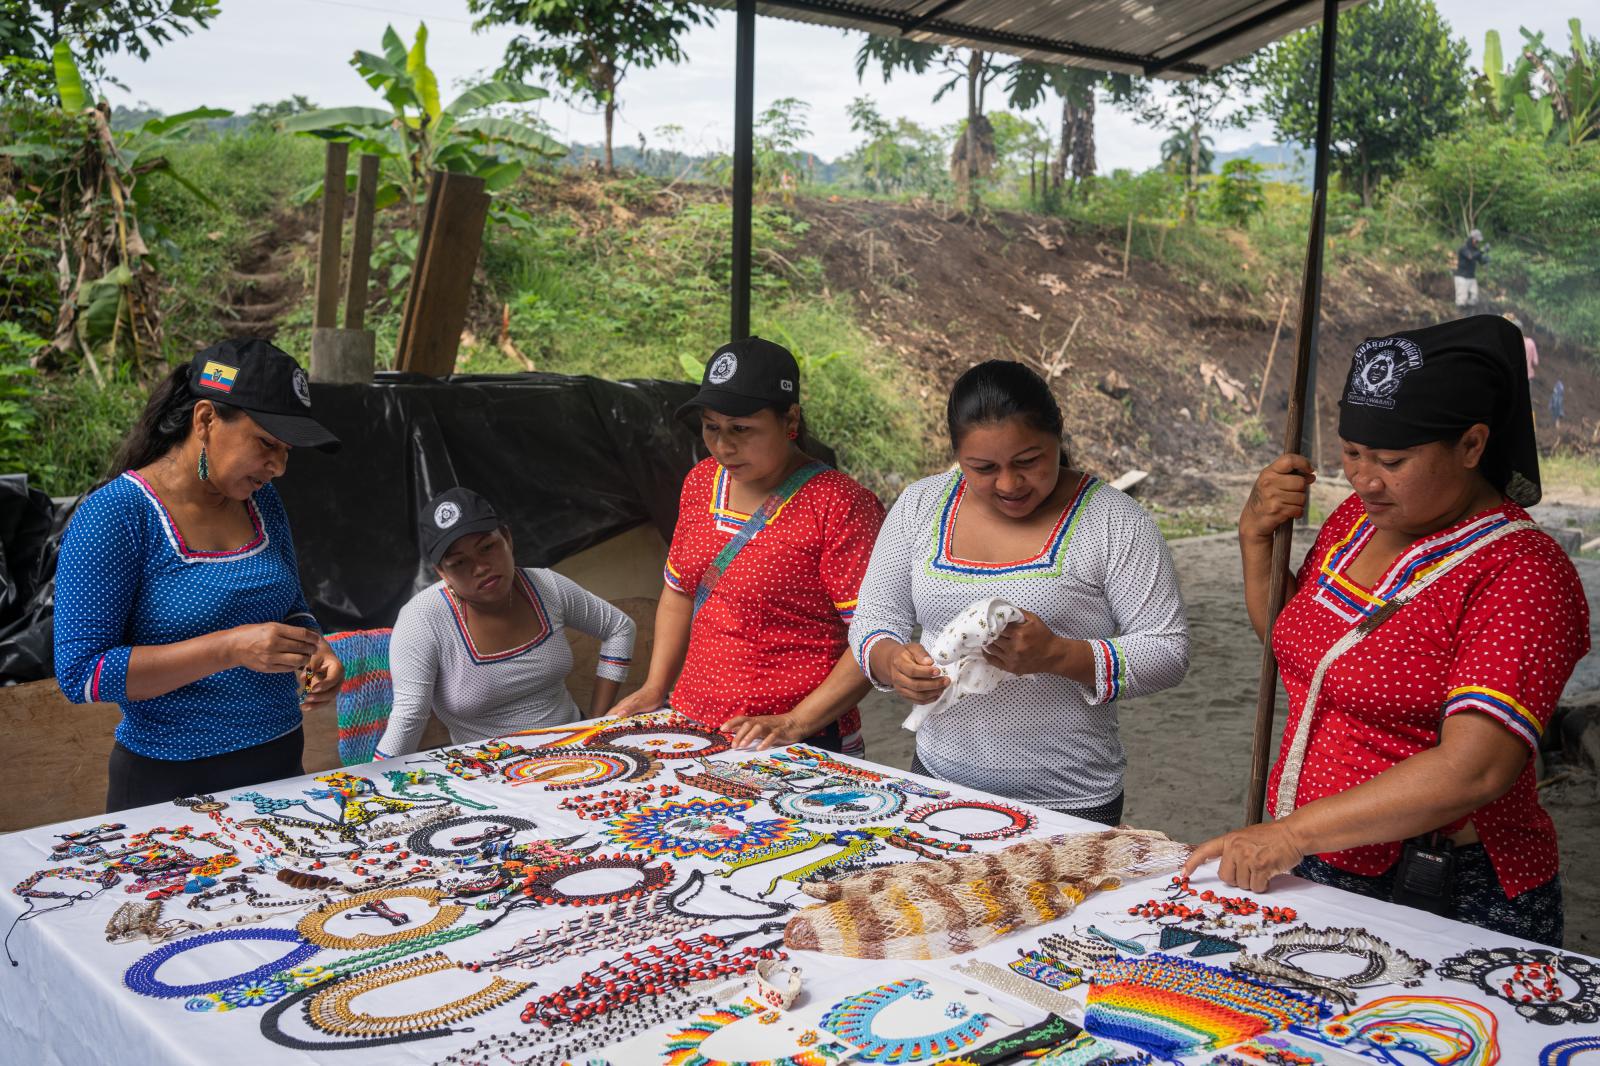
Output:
[{"xmin": 0, "ymin": 0, "xmax": 219, "ymax": 101}]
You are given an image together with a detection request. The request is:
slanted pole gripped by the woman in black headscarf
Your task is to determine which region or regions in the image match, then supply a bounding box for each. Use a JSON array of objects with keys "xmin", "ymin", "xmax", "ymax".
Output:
[{"xmin": 1245, "ymin": 0, "xmax": 1339, "ymax": 826}]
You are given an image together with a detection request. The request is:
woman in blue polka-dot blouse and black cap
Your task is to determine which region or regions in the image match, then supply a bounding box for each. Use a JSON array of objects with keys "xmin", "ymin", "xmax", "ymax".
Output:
[{"xmin": 54, "ymin": 339, "xmax": 344, "ymax": 812}]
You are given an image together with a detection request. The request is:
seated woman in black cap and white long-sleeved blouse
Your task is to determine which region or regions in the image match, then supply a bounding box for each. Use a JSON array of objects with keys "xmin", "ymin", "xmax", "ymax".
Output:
[{"xmin": 376, "ymin": 488, "xmax": 634, "ymax": 759}]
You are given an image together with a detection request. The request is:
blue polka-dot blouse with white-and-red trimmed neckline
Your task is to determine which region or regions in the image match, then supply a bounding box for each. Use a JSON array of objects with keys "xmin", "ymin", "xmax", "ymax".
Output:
[{"xmin": 54, "ymin": 471, "xmax": 318, "ymax": 760}]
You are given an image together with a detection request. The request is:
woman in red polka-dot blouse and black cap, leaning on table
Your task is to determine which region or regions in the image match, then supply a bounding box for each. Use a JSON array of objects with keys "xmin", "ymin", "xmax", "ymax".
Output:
[{"xmin": 614, "ymin": 336, "xmax": 883, "ymax": 754}]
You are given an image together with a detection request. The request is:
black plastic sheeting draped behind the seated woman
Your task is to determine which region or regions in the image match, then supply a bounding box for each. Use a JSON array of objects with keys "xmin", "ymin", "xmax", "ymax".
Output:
[{"xmin": 0, "ymin": 373, "xmax": 834, "ymax": 682}]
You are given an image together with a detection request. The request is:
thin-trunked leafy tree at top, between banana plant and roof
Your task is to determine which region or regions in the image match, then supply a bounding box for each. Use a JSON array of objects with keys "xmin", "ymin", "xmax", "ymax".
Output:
[{"xmin": 467, "ymin": 0, "xmax": 714, "ymax": 173}]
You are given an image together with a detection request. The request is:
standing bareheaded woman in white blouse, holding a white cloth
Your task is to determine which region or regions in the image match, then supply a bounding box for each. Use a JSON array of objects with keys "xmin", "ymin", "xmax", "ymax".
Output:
[{"xmin": 850, "ymin": 360, "xmax": 1189, "ymax": 823}]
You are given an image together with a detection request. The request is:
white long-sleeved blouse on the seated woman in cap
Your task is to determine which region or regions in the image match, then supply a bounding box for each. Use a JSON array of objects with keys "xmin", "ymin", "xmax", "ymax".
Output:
[{"xmin": 378, "ymin": 567, "xmax": 634, "ymax": 759}]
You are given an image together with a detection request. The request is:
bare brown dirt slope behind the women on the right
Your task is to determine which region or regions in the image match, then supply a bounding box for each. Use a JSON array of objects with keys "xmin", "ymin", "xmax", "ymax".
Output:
[{"xmin": 795, "ymin": 200, "xmax": 1600, "ymax": 503}]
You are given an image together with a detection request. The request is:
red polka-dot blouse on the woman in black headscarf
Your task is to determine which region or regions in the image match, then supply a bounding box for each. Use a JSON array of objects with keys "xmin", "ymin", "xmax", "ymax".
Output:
[{"xmin": 1267, "ymin": 495, "xmax": 1589, "ymax": 896}]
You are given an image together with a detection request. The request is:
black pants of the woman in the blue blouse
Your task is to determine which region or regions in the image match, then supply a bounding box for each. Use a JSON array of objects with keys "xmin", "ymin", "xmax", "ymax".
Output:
[{"xmin": 106, "ymin": 730, "xmax": 306, "ymax": 813}]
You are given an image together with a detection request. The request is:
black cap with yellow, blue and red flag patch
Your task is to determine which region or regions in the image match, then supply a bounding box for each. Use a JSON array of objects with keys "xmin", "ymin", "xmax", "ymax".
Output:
[{"xmin": 189, "ymin": 336, "xmax": 339, "ymax": 451}]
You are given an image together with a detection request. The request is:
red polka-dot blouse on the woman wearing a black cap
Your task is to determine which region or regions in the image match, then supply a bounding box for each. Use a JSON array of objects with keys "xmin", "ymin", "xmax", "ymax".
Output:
[{"xmin": 664, "ymin": 459, "xmax": 883, "ymax": 738}]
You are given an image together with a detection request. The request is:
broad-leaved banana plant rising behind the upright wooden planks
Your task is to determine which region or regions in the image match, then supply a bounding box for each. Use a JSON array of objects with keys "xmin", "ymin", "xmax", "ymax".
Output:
[{"xmin": 283, "ymin": 24, "xmax": 566, "ymax": 221}]
